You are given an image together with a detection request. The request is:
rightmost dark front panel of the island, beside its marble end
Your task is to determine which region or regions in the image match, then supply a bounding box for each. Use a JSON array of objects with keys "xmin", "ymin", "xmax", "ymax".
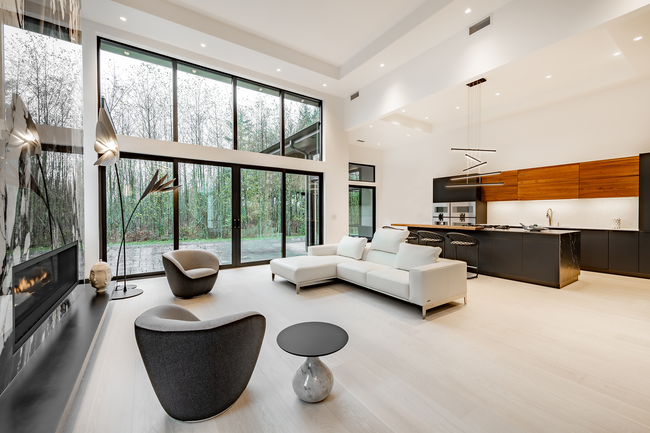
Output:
[{"xmin": 522, "ymin": 236, "xmax": 560, "ymax": 285}]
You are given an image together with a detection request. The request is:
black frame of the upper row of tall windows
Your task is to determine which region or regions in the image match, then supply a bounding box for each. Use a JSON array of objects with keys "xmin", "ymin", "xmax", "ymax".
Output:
[{"xmin": 96, "ymin": 36, "xmax": 324, "ymax": 157}]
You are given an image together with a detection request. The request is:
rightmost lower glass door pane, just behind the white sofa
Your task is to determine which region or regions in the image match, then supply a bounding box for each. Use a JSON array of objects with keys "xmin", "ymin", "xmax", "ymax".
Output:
[{"xmin": 285, "ymin": 173, "xmax": 321, "ymax": 257}]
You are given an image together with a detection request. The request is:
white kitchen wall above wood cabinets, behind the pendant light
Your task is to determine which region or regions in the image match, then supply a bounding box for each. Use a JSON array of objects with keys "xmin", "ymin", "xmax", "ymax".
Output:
[{"xmin": 383, "ymin": 80, "xmax": 650, "ymax": 227}]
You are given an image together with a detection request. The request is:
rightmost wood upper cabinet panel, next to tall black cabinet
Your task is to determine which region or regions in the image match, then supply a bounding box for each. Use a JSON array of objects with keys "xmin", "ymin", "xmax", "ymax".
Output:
[{"xmin": 580, "ymin": 156, "xmax": 639, "ymax": 198}]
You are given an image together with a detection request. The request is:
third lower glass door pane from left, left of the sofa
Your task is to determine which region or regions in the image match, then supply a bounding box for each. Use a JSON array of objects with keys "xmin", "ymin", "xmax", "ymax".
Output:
[{"xmin": 237, "ymin": 168, "xmax": 282, "ymax": 263}]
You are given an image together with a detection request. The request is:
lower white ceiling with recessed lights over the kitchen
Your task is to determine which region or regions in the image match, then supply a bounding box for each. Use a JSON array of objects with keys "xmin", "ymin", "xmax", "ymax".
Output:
[{"xmin": 349, "ymin": 8, "xmax": 650, "ymax": 149}]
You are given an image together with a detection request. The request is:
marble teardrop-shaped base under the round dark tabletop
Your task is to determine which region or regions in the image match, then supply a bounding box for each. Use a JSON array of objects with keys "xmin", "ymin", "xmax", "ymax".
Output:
[{"xmin": 293, "ymin": 357, "xmax": 334, "ymax": 403}]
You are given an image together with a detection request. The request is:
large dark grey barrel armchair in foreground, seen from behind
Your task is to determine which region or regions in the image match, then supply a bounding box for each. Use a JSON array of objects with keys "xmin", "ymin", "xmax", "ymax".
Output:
[{"xmin": 135, "ymin": 305, "xmax": 266, "ymax": 421}]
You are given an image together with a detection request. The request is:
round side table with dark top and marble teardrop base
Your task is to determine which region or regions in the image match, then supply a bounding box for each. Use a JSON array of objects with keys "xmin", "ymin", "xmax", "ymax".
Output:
[{"xmin": 277, "ymin": 322, "xmax": 348, "ymax": 403}]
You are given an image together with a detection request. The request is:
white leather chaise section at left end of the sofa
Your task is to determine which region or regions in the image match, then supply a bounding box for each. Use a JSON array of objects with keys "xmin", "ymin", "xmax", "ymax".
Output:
[{"xmin": 271, "ymin": 256, "xmax": 355, "ymax": 284}]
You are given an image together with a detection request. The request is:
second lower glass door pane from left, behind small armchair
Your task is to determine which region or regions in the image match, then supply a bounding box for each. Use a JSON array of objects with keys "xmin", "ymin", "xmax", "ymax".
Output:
[{"xmin": 178, "ymin": 163, "xmax": 233, "ymax": 265}]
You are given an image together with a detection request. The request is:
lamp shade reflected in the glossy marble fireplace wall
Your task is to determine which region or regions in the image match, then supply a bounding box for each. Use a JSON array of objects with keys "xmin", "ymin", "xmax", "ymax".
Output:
[{"xmin": 7, "ymin": 93, "xmax": 41, "ymax": 157}]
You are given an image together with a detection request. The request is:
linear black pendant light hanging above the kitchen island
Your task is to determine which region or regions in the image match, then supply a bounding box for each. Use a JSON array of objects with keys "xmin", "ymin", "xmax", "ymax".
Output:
[{"xmin": 446, "ymin": 78, "xmax": 503, "ymax": 188}]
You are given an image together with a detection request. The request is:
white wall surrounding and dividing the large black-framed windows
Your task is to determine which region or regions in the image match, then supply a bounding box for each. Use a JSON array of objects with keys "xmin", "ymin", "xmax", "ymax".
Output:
[{"xmin": 82, "ymin": 20, "xmax": 348, "ymax": 276}]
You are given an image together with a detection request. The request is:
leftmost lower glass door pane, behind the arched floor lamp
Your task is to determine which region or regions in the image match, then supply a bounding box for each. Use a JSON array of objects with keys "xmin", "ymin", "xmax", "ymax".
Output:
[{"xmin": 106, "ymin": 157, "xmax": 174, "ymax": 275}]
